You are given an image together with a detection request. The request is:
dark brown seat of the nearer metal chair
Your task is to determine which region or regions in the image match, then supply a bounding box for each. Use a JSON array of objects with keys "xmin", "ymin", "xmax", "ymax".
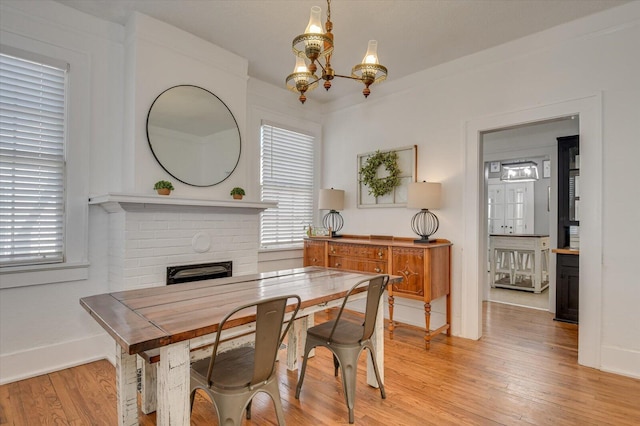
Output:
[{"xmin": 191, "ymin": 346, "xmax": 255, "ymax": 389}]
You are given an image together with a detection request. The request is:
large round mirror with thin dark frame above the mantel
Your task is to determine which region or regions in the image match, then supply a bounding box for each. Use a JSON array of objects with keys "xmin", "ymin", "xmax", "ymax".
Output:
[{"xmin": 147, "ymin": 85, "xmax": 240, "ymax": 186}]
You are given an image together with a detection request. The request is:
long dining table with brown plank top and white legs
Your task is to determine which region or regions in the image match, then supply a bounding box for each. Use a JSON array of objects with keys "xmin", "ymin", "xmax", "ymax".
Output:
[{"xmin": 80, "ymin": 267, "xmax": 401, "ymax": 426}]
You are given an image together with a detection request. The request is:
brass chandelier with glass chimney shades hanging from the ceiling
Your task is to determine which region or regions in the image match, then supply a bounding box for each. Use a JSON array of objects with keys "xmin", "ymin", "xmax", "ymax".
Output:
[{"xmin": 286, "ymin": 0, "xmax": 387, "ymax": 104}]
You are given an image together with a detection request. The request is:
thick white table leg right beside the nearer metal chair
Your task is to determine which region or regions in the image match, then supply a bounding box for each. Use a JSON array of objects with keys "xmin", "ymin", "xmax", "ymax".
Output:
[{"xmin": 156, "ymin": 340, "xmax": 191, "ymax": 426}]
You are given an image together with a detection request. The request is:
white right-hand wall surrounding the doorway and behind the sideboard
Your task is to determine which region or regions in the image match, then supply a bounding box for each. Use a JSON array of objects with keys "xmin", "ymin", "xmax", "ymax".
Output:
[{"xmin": 323, "ymin": 2, "xmax": 640, "ymax": 377}]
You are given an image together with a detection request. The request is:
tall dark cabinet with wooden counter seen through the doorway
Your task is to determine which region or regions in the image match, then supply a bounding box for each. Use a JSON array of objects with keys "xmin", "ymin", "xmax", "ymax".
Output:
[{"xmin": 553, "ymin": 135, "xmax": 580, "ymax": 323}]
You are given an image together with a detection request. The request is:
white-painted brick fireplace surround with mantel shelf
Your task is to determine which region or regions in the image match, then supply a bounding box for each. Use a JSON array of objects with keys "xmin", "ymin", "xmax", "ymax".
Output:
[{"xmin": 89, "ymin": 194, "xmax": 276, "ymax": 291}]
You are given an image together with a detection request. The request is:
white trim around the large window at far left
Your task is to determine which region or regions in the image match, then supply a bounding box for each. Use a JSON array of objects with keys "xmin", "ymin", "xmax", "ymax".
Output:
[{"xmin": 0, "ymin": 40, "xmax": 91, "ymax": 289}]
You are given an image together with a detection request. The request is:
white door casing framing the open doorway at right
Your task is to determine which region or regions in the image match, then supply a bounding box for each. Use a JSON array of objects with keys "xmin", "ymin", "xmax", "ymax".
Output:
[{"xmin": 460, "ymin": 93, "xmax": 603, "ymax": 368}]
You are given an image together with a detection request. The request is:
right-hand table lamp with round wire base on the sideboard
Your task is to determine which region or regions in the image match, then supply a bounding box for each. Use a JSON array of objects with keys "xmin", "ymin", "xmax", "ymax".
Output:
[{"xmin": 407, "ymin": 181, "xmax": 442, "ymax": 243}]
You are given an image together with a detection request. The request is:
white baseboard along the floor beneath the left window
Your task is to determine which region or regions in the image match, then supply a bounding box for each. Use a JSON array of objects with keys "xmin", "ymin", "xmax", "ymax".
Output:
[{"xmin": 0, "ymin": 333, "xmax": 115, "ymax": 385}]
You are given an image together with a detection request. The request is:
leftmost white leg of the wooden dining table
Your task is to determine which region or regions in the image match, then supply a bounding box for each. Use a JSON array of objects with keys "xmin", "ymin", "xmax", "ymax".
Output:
[{"xmin": 116, "ymin": 343, "xmax": 138, "ymax": 426}]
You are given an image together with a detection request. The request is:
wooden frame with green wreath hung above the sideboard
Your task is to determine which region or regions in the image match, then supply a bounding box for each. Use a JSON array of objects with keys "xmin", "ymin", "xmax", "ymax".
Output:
[{"xmin": 358, "ymin": 145, "xmax": 418, "ymax": 208}]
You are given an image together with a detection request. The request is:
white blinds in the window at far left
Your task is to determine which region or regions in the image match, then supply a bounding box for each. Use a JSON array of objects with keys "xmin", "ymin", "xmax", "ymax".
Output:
[{"xmin": 0, "ymin": 54, "xmax": 66, "ymax": 266}]
